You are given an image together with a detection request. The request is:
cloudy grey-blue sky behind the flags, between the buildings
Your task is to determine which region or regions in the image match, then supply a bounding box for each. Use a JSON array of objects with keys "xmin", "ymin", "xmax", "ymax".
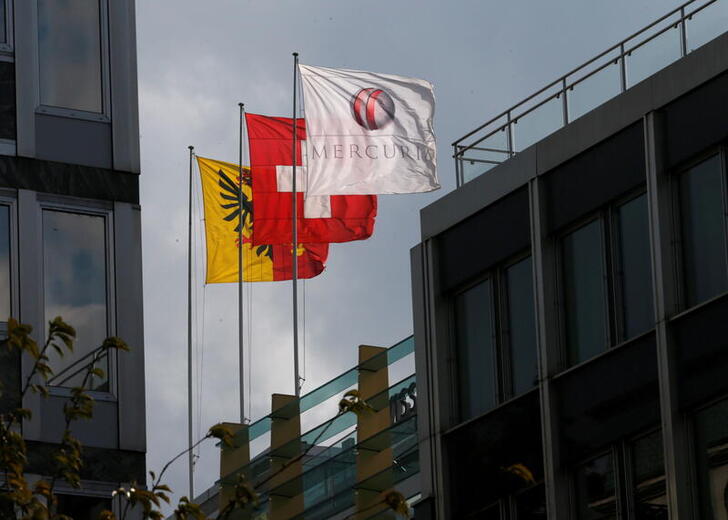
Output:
[{"xmin": 137, "ymin": 0, "xmax": 678, "ymax": 512}]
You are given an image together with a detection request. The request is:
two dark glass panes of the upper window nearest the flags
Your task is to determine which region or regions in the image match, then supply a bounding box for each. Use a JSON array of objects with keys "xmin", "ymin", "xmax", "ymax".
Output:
[{"xmin": 455, "ymin": 257, "xmax": 538, "ymax": 420}]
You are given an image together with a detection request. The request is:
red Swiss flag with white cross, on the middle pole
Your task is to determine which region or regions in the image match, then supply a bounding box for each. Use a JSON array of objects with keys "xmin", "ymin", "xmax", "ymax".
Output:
[{"xmin": 245, "ymin": 114, "xmax": 377, "ymax": 245}]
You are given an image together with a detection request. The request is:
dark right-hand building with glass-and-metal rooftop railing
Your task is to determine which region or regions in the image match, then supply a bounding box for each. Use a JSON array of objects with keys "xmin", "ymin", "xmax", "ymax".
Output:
[{"xmin": 411, "ymin": 1, "xmax": 728, "ymax": 520}]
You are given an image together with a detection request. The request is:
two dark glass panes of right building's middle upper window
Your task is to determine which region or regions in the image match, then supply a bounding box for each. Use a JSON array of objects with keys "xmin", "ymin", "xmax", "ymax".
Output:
[{"xmin": 561, "ymin": 193, "xmax": 655, "ymax": 366}]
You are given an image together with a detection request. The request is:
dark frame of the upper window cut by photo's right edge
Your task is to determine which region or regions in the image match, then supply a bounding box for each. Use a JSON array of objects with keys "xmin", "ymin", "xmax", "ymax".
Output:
[{"xmin": 668, "ymin": 145, "xmax": 728, "ymax": 314}]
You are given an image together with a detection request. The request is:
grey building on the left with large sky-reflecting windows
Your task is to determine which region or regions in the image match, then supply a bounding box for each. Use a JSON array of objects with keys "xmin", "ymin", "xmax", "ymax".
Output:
[{"xmin": 0, "ymin": 0, "xmax": 146, "ymax": 518}]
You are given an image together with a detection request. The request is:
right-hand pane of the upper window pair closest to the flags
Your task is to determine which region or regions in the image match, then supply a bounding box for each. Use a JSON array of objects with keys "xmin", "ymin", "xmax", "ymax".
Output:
[{"xmin": 505, "ymin": 256, "xmax": 538, "ymax": 395}]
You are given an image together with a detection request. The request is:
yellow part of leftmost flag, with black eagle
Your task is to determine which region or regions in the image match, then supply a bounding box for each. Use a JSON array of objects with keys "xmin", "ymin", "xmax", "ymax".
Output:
[{"xmin": 197, "ymin": 157, "xmax": 275, "ymax": 283}]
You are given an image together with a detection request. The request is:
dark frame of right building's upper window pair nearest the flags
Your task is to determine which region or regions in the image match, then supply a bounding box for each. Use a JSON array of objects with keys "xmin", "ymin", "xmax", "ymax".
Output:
[{"xmin": 448, "ymin": 248, "xmax": 540, "ymax": 424}]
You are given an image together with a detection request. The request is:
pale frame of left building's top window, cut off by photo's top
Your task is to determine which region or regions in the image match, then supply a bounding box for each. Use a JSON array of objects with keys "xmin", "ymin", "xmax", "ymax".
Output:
[{"xmin": 34, "ymin": 0, "xmax": 111, "ymax": 122}]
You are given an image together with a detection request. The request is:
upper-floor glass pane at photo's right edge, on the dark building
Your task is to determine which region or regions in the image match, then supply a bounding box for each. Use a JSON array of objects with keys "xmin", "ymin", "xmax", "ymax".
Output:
[{"xmin": 680, "ymin": 154, "xmax": 728, "ymax": 307}]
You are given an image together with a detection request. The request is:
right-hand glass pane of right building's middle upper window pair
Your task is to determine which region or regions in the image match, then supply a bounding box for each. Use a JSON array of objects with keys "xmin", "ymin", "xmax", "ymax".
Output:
[{"xmin": 615, "ymin": 194, "xmax": 655, "ymax": 339}]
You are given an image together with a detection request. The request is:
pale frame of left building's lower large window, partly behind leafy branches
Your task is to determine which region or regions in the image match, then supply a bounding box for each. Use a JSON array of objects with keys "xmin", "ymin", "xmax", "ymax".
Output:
[{"xmin": 38, "ymin": 195, "xmax": 119, "ymax": 401}]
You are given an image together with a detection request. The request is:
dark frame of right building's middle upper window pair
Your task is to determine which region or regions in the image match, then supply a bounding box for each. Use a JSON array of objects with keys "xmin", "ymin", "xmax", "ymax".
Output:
[{"xmin": 554, "ymin": 189, "xmax": 654, "ymax": 372}]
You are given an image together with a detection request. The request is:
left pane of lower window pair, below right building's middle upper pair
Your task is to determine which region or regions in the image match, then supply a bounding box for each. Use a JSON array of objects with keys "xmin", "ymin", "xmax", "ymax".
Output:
[{"xmin": 574, "ymin": 453, "xmax": 617, "ymax": 520}]
